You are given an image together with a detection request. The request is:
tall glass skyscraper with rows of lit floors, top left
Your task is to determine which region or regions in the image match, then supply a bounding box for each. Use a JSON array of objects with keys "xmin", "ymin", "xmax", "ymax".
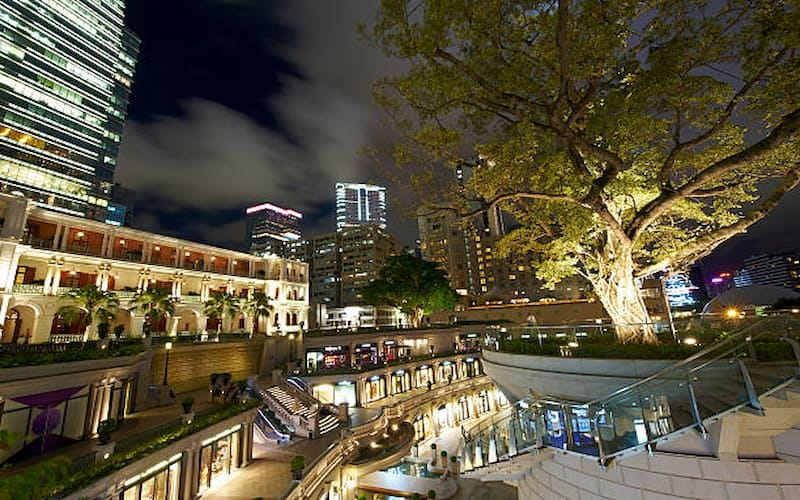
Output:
[{"xmin": 0, "ymin": 0, "xmax": 139, "ymax": 221}]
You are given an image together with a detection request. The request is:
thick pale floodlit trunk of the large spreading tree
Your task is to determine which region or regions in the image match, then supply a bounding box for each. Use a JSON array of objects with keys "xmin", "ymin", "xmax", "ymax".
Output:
[{"xmin": 590, "ymin": 247, "xmax": 658, "ymax": 344}]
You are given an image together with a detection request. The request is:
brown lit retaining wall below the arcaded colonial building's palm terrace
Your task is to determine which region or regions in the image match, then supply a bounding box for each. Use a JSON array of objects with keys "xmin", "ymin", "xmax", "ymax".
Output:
[{"xmin": 150, "ymin": 340, "xmax": 264, "ymax": 394}]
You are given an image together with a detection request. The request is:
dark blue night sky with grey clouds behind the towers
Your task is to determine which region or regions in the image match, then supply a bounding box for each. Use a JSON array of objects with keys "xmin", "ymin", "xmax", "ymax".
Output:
[{"xmin": 116, "ymin": 0, "xmax": 800, "ymax": 278}]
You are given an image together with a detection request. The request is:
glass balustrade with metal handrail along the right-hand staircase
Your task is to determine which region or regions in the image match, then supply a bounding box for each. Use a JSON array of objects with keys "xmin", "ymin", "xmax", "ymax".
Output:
[{"xmin": 460, "ymin": 317, "xmax": 800, "ymax": 472}]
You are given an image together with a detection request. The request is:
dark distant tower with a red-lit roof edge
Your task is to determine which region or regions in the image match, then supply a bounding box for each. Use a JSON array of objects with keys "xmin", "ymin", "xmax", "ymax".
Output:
[{"xmin": 245, "ymin": 203, "xmax": 303, "ymax": 255}]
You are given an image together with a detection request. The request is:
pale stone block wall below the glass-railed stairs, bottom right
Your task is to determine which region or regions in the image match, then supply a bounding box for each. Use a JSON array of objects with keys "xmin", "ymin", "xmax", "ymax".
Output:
[{"xmin": 512, "ymin": 451, "xmax": 800, "ymax": 500}]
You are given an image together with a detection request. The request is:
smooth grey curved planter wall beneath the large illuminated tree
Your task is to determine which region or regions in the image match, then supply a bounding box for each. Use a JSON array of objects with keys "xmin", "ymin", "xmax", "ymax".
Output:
[{"xmin": 482, "ymin": 350, "xmax": 675, "ymax": 402}]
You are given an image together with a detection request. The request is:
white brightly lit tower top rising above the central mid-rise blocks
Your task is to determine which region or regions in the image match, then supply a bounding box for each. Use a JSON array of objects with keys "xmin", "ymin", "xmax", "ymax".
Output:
[{"xmin": 336, "ymin": 182, "xmax": 386, "ymax": 231}]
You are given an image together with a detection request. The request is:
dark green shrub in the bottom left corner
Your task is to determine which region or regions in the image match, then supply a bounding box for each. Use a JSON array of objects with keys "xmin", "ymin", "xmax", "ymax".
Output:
[{"xmin": 0, "ymin": 456, "xmax": 70, "ymax": 500}]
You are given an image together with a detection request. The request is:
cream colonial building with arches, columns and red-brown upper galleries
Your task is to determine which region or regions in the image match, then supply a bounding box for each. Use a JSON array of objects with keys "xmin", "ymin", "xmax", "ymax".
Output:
[{"xmin": 0, "ymin": 194, "xmax": 309, "ymax": 343}]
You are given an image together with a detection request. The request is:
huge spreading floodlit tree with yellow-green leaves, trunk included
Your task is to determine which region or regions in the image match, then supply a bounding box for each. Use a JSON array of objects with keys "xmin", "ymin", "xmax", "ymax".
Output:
[{"xmin": 363, "ymin": 0, "xmax": 800, "ymax": 342}]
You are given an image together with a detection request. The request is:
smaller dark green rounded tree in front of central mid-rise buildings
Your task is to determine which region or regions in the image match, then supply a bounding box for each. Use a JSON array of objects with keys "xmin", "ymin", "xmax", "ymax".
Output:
[{"xmin": 362, "ymin": 254, "xmax": 456, "ymax": 327}]
